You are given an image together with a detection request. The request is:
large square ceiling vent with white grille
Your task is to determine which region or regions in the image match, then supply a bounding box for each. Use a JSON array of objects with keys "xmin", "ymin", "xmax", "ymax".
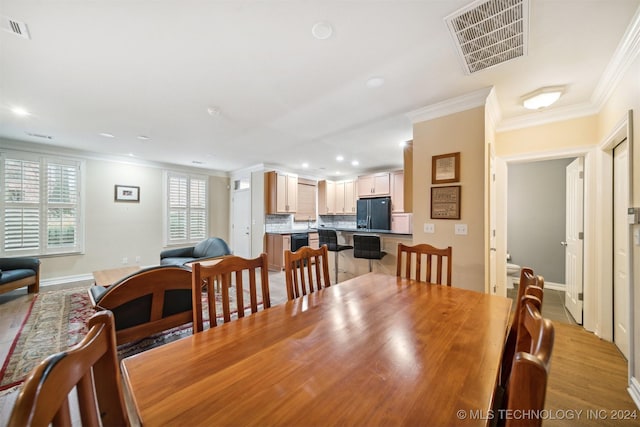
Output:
[{"xmin": 445, "ymin": 0, "xmax": 529, "ymax": 74}]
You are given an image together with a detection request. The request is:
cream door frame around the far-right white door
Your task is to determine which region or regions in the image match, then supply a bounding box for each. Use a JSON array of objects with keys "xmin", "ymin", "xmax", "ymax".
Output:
[{"xmin": 594, "ymin": 110, "xmax": 635, "ymax": 379}]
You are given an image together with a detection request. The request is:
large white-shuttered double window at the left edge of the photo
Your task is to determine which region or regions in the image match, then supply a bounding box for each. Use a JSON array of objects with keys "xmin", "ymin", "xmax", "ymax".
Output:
[{"xmin": 0, "ymin": 153, "xmax": 83, "ymax": 256}]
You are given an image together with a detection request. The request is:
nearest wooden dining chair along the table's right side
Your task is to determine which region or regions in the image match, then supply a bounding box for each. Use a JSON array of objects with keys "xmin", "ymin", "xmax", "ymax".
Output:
[{"xmin": 499, "ymin": 296, "xmax": 554, "ymax": 427}]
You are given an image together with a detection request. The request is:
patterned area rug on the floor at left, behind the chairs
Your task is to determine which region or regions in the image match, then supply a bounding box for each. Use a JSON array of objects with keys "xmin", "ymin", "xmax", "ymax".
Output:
[{"xmin": 0, "ymin": 287, "xmax": 260, "ymax": 391}]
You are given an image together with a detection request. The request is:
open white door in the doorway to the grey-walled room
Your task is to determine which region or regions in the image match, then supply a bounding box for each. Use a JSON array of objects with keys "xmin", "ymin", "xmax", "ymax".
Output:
[{"xmin": 561, "ymin": 157, "xmax": 584, "ymax": 324}]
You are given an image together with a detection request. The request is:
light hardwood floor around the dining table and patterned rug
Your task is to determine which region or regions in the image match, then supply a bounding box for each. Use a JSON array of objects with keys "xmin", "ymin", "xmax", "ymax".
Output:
[{"xmin": 0, "ymin": 272, "xmax": 640, "ymax": 426}]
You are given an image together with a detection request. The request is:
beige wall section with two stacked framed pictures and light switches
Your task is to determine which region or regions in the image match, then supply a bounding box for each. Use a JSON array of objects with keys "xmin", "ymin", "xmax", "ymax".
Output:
[{"xmin": 413, "ymin": 107, "xmax": 485, "ymax": 292}]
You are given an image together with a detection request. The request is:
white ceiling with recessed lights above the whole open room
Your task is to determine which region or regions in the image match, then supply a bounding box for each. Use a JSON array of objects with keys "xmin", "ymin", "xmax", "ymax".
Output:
[{"xmin": 0, "ymin": 0, "xmax": 640, "ymax": 177}]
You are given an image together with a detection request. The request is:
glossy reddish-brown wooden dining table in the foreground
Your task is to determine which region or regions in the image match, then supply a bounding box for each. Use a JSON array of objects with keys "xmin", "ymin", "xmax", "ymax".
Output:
[{"xmin": 122, "ymin": 273, "xmax": 511, "ymax": 426}]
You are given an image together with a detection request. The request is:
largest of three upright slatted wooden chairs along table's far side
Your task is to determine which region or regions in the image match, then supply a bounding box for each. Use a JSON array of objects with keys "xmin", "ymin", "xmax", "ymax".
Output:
[{"xmin": 191, "ymin": 253, "xmax": 271, "ymax": 333}]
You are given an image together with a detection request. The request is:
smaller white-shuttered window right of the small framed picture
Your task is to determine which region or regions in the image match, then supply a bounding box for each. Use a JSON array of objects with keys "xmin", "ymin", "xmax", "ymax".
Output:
[{"xmin": 165, "ymin": 172, "xmax": 208, "ymax": 245}]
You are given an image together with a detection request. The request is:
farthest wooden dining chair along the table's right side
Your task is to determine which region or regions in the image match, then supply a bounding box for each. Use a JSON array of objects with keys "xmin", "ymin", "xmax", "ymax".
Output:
[{"xmin": 500, "ymin": 267, "xmax": 544, "ymax": 385}]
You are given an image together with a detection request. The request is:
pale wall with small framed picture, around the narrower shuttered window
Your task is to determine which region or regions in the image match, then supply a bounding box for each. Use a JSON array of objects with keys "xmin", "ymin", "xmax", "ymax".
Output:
[{"xmin": 0, "ymin": 141, "xmax": 229, "ymax": 281}]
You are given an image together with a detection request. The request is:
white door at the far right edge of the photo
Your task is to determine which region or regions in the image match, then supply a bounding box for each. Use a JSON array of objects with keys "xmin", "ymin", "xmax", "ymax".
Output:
[{"xmin": 613, "ymin": 141, "xmax": 630, "ymax": 360}]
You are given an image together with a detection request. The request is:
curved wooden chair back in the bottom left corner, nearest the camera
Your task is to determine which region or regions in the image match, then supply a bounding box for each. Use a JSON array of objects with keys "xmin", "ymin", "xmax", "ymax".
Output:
[{"xmin": 8, "ymin": 310, "xmax": 130, "ymax": 426}]
